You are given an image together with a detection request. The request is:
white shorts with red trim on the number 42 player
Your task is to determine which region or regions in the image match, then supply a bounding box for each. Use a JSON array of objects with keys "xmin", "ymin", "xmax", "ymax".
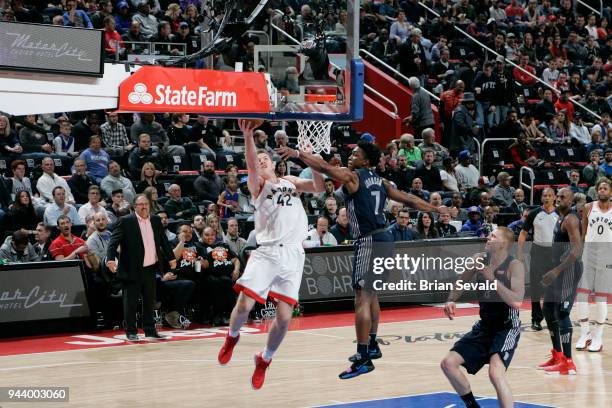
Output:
[{"xmin": 234, "ymin": 244, "xmax": 306, "ymax": 305}]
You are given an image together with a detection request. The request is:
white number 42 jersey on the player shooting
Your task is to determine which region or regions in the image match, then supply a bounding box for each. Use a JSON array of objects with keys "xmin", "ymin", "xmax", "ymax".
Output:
[{"xmin": 253, "ymin": 178, "xmax": 308, "ymax": 246}]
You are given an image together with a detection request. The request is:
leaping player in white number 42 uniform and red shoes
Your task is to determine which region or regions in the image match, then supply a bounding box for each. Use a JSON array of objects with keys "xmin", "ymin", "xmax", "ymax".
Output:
[{"xmin": 218, "ymin": 120, "xmax": 325, "ymax": 389}]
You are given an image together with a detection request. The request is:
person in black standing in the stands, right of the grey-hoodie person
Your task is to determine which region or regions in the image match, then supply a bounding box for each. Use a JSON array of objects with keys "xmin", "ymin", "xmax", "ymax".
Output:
[{"xmin": 449, "ymin": 92, "xmax": 480, "ymax": 153}]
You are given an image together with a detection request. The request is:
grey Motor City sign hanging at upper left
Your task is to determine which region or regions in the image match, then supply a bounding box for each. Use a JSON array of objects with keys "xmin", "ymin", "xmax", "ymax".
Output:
[{"xmin": 0, "ymin": 22, "xmax": 104, "ymax": 77}]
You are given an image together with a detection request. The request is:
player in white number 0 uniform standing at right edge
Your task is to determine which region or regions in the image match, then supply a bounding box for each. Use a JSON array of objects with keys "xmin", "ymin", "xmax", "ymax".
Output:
[{"xmin": 576, "ymin": 178, "xmax": 612, "ymax": 352}]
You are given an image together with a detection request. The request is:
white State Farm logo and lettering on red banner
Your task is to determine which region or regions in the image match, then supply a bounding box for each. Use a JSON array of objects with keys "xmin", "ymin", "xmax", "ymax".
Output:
[{"xmin": 128, "ymin": 82, "xmax": 238, "ymax": 108}]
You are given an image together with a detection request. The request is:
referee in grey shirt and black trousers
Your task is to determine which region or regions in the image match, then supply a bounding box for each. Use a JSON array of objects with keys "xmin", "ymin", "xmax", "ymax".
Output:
[{"xmin": 518, "ymin": 188, "xmax": 559, "ymax": 331}]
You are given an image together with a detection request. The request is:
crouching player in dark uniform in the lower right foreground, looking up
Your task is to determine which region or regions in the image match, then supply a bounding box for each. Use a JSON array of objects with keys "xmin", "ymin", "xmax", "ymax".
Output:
[{"xmin": 441, "ymin": 227, "xmax": 525, "ymax": 408}]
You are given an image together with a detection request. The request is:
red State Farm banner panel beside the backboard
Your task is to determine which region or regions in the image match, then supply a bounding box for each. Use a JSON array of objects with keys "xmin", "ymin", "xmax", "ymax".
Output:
[{"xmin": 119, "ymin": 66, "xmax": 270, "ymax": 114}]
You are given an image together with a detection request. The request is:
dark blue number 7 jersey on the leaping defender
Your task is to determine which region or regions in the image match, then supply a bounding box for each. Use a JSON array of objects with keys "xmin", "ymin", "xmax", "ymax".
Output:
[{"xmin": 344, "ymin": 169, "xmax": 387, "ymax": 238}]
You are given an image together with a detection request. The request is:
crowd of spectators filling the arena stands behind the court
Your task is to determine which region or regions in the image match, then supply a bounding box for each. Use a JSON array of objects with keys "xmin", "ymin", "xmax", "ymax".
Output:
[{"xmin": 0, "ymin": 0, "xmax": 612, "ymax": 327}]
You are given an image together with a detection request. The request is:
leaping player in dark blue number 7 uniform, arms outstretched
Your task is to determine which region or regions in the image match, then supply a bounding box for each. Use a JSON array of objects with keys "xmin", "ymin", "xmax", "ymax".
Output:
[{"xmin": 277, "ymin": 142, "xmax": 447, "ymax": 379}]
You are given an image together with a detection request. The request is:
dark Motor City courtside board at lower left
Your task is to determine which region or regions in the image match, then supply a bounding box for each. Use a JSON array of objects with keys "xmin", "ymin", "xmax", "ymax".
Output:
[{"xmin": 0, "ymin": 262, "xmax": 90, "ymax": 323}]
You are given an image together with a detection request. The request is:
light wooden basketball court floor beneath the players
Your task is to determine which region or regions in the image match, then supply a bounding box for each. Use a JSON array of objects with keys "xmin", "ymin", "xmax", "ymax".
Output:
[{"xmin": 0, "ymin": 306, "xmax": 612, "ymax": 408}]
